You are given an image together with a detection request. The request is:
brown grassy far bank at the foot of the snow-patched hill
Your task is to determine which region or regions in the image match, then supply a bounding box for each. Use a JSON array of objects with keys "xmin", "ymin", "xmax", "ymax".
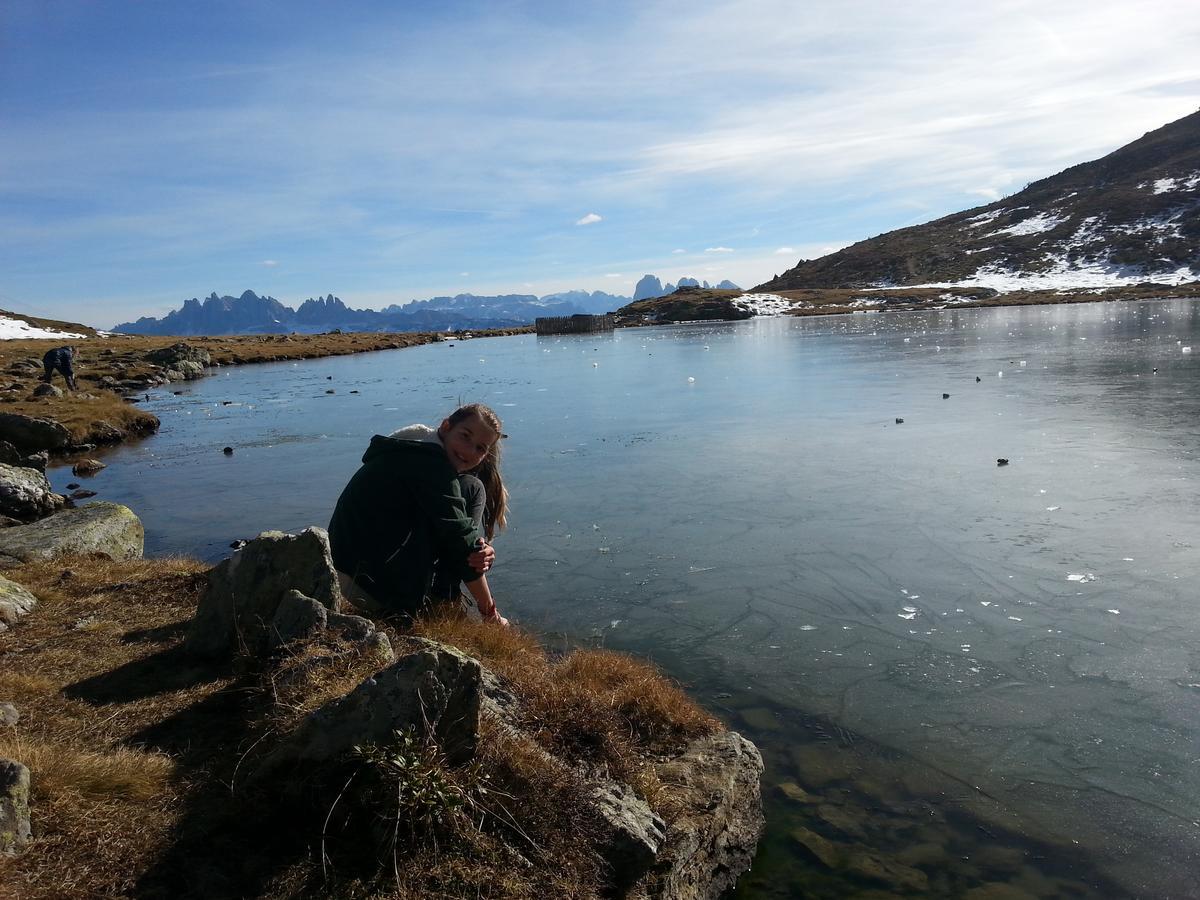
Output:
[{"xmin": 617, "ymin": 282, "xmax": 1200, "ymax": 328}]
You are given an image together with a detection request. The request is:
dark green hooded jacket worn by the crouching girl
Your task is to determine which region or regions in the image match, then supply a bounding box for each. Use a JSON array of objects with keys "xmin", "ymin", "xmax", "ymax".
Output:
[{"xmin": 329, "ymin": 434, "xmax": 482, "ymax": 614}]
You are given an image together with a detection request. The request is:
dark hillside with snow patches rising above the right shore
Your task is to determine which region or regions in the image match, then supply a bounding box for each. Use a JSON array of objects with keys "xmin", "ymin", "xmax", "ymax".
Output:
[{"xmin": 755, "ymin": 112, "xmax": 1200, "ymax": 290}]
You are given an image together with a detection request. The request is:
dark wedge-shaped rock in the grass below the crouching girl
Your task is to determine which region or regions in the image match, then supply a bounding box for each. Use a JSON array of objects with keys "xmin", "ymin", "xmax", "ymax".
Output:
[{"xmin": 253, "ymin": 641, "xmax": 481, "ymax": 781}]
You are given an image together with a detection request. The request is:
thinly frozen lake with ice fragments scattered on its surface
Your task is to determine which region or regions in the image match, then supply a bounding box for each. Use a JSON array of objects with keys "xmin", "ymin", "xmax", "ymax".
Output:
[{"xmin": 52, "ymin": 301, "xmax": 1200, "ymax": 896}]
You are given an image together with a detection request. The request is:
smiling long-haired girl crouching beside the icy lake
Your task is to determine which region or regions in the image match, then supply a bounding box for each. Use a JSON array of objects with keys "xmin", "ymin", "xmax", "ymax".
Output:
[{"xmin": 329, "ymin": 403, "xmax": 508, "ymax": 625}]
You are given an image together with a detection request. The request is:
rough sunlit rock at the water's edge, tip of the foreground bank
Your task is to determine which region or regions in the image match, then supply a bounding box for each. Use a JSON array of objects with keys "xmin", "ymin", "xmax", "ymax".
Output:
[{"xmin": 653, "ymin": 731, "xmax": 763, "ymax": 900}]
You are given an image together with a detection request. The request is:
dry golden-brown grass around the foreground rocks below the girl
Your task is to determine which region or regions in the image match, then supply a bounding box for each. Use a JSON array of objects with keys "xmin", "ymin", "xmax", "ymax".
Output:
[{"xmin": 0, "ymin": 557, "xmax": 720, "ymax": 900}]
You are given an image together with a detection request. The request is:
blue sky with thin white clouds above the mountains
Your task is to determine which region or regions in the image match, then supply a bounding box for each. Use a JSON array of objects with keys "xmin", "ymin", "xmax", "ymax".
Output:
[{"xmin": 0, "ymin": 0, "xmax": 1200, "ymax": 326}]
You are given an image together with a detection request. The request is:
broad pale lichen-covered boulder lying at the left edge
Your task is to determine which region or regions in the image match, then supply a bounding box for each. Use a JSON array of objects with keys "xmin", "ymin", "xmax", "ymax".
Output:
[{"xmin": 0, "ymin": 502, "xmax": 145, "ymax": 566}]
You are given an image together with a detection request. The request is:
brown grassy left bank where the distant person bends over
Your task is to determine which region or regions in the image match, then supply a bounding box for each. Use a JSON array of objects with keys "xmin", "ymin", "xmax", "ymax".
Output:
[{"xmin": 0, "ymin": 328, "xmax": 532, "ymax": 454}]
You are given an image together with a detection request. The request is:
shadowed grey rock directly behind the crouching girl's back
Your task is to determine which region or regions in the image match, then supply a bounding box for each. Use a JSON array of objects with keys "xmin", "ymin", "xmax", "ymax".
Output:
[{"xmin": 184, "ymin": 528, "xmax": 342, "ymax": 656}]
